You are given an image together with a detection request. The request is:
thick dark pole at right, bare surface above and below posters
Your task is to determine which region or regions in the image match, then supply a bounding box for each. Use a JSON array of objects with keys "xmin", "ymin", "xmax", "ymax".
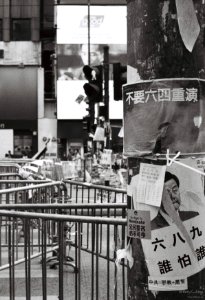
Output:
[{"xmin": 127, "ymin": 0, "xmax": 205, "ymax": 300}]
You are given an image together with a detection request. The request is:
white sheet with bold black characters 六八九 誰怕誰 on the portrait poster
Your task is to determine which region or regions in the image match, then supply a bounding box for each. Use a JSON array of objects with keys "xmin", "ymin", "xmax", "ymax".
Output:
[{"xmin": 142, "ymin": 211, "xmax": 205, "ymax": 278}]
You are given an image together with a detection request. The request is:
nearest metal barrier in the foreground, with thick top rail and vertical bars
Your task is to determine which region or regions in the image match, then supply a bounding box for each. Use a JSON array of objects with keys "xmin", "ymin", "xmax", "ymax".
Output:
[{"xmin": 0, "ymin": 204, "xmax": 127, "ymax": 300}]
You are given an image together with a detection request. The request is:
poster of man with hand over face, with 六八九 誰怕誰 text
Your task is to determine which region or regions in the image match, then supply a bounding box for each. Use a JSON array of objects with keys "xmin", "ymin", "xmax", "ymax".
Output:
[{"xmin": 139, "ymin": 158, "xmax": 205, "ymax": 281}]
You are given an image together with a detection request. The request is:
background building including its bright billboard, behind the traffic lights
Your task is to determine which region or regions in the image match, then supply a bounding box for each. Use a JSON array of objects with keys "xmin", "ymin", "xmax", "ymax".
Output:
[{"xmin": 0, "ymin": 0, "xmax": 126, "ymax": 158}]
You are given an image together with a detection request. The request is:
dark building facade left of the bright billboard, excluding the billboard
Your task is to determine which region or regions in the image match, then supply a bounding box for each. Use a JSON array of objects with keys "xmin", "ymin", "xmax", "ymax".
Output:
[{"xmin": 0, "ymin": 0, "xmax": 126, "ymax": 158}]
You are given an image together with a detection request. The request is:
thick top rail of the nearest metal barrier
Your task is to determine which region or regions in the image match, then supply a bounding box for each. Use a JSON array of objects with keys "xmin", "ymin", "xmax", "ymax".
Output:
[{"xmin": 0, "ymin": 210, "xmax": 127, "ymax": 225}]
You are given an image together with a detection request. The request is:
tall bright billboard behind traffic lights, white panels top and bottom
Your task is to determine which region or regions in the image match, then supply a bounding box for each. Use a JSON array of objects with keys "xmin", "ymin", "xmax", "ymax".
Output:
[{"xmin": 57, "ymin": 5, "xmax": 127, "ymax": 120}]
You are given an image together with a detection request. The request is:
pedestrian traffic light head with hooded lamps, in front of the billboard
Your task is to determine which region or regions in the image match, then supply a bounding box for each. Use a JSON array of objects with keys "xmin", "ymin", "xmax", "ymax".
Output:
[{"xmin": 83, "ymin": 65, "xmax": 103, "ymax": 103}]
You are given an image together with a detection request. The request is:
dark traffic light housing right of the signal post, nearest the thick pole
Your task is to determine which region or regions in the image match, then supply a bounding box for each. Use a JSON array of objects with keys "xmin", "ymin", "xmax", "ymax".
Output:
[{"xmin": 113, "ymin": 63, "xmax": 127, "ymax": 101}]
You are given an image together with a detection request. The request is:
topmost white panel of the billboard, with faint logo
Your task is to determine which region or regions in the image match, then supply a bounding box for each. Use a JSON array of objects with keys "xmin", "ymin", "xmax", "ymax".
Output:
[{"xmin": 57, "ymin": 5, "xmax": 127, "ymax": 44}]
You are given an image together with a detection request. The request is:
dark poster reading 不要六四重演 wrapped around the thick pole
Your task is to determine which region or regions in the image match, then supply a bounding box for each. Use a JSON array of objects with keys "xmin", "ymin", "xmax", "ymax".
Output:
[{"xmin": 123, "ymin": 78, "xmax": 205, "ymax": 156}]
